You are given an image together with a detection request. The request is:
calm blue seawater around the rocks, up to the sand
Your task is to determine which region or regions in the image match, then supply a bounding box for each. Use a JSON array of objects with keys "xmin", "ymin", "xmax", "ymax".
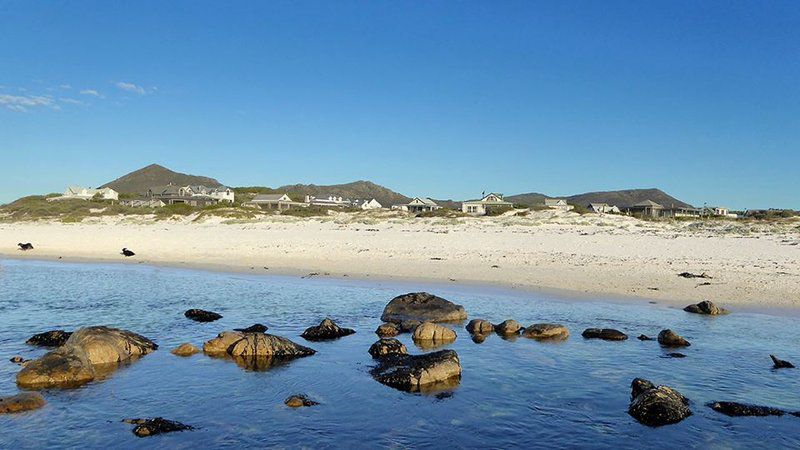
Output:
[{"xmin": 0, "ymin": 261, "xmax": 800, "ymax": 448}]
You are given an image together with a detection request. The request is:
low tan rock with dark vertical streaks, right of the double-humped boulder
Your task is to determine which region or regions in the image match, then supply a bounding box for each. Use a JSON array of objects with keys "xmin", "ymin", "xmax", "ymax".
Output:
[{"xmin": 203, "ymin": 331, "xmax": 316, "ymax": 358}]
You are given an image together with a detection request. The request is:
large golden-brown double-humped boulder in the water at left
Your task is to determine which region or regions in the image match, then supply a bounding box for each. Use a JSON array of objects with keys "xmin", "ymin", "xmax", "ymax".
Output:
[{"xmin": 17, "ymin": 327, "xmax": 158, "ymax": 389}]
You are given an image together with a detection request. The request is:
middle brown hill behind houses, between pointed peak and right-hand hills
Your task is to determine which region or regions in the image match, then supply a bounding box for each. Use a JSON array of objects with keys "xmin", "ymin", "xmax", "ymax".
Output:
[{"xmin": 235, "ymin": 181, "xmax": 411, "ymax": 208}]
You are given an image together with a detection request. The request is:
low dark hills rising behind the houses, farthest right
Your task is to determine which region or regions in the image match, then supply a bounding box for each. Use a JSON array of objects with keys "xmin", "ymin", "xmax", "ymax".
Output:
[{"xmin": 505, "ymin": 188, "xmax": 691, "ymax": 208}]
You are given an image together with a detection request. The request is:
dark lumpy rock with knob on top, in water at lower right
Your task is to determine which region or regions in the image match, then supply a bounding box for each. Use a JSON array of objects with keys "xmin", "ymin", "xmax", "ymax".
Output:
[{"xmin": 628, "ymin": 378, "xmax": 692, "ymax": 427}]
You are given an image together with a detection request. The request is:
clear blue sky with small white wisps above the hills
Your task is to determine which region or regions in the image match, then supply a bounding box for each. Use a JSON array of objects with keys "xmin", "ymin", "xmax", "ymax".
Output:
[{"xmin": 0, "ymin": 0, "xmax": 800, "ymax": 209}]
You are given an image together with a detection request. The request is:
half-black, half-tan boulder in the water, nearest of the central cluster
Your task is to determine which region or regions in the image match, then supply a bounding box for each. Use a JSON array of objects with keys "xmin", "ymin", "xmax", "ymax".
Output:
[{"xmin": 371, "ymin": 350, "xmax": 461, "ymax": 392}]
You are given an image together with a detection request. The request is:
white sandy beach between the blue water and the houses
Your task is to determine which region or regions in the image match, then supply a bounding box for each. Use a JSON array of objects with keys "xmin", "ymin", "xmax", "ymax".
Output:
[{"xmin": 0, "ymin": 212, "xmax": 800, "ymax": 308}]
